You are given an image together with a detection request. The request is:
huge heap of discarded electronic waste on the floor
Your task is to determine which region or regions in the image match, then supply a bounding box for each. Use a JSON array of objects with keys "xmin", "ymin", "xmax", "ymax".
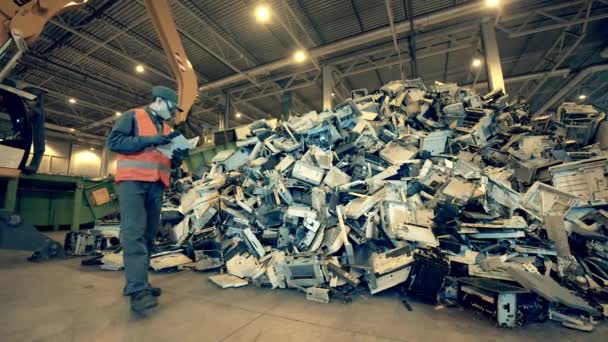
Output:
[{"xmin": 83, "ymin": 79, "xmax": 608, "ymax": 330}]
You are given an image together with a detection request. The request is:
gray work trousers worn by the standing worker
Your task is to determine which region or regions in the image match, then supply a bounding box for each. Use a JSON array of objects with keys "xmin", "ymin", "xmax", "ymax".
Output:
[{"xmin": 118, "ymin": 181, "xmax": 164, "ymax": 295}]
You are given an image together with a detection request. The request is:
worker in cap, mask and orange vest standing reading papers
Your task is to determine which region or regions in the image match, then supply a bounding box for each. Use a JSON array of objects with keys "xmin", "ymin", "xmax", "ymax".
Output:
[{"xmin": 108, "ymin": 86, "xmax": 188, "ymax": 312}]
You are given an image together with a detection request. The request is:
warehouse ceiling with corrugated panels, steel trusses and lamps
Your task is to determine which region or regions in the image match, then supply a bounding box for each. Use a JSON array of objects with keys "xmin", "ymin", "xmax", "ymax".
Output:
[{"xmin": 5, "ymin": 0, "xmax": 608, "ymax": 138}]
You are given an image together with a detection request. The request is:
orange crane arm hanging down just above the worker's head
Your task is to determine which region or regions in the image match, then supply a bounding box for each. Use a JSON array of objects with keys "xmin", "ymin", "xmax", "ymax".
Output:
[{"xmin": 144, "ymin": 0, "xmax": 198, "ymax": 124}]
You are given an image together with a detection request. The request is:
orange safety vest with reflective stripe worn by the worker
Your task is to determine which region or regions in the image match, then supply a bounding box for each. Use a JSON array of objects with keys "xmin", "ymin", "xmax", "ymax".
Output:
[{"xmin": 115, "ymin": 108, "xmax": 171, "ymax": 187}]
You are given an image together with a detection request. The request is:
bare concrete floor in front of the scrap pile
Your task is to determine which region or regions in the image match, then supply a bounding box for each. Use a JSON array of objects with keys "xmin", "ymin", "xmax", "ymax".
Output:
[{"xmin": 0, "ymin": 231, "xmax": 608, "ymax": 342}]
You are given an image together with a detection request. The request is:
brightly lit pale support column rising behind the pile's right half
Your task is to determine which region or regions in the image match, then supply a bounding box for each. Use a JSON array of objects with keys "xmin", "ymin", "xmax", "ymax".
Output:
[{"xmin": 481, "ymin": 18, "xmax": 507, "ymax": 93}]
